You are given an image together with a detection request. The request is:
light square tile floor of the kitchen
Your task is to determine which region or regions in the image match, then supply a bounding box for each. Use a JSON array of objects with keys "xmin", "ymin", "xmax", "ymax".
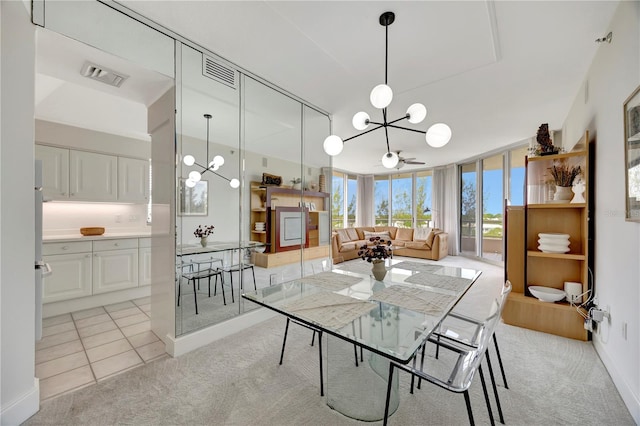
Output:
[{"xmin": 36, "ymin": 297, "xmax": 168, "ymax": 401}]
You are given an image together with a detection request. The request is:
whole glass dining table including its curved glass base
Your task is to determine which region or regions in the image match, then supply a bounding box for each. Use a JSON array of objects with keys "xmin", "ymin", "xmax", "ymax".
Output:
[{"xmin": 242, "ymin": 259, "xmax": 481, "ymax": 421}]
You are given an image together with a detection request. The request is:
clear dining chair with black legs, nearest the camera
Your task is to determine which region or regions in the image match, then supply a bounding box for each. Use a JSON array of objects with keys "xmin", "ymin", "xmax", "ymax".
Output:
[{"xmin": 384, "ymin": 281, "xmax": 511, "ymax": 425}]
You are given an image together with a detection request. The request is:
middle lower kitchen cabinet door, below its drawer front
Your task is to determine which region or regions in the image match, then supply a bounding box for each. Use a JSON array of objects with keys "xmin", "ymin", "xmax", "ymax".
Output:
[{"xmin": 93, "ymin": 248, "xmax": 138, "ymax": 294}]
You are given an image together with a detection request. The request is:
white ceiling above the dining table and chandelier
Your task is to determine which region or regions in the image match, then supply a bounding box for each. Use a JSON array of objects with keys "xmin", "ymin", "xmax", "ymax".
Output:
[{"xmin": 37, "ymin": 0, "xmax": 617, "ymax": 173}]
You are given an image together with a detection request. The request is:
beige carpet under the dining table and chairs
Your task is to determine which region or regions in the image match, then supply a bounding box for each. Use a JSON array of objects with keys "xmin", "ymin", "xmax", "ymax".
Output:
[{"xmin": 25, "ymin": 258, "xmax": 634, "ymax": 425}]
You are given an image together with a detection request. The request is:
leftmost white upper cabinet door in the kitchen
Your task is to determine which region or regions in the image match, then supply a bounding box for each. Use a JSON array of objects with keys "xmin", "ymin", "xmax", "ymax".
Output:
[{"xmin": 36, "ymin": 145, "xmax": 69, "ymax": 200}]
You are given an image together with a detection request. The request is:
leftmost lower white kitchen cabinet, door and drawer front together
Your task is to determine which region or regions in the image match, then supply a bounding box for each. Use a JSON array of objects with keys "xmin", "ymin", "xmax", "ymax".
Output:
[{"xmin": 42, "ymin": 241, "xmax": 93, "ymax": 303}]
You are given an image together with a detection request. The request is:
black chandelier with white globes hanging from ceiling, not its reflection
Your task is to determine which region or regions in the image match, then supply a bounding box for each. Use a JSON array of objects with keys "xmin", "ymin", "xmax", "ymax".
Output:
[{"xmin": 323, "ymin": 12, "xmax": 451, "ymax": 169}]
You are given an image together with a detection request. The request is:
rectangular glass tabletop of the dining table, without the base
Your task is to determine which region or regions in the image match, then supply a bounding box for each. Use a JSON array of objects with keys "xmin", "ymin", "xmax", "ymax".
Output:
[{"xmin": 243, "ymin": 262, "xmax": 480, "ymax": 363}]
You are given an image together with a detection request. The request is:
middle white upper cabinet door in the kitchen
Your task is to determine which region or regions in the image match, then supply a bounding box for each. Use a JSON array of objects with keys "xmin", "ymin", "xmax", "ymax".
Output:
[{"xmin": 69, "ymin": 151, "xmax": 118, "ymax": 201}]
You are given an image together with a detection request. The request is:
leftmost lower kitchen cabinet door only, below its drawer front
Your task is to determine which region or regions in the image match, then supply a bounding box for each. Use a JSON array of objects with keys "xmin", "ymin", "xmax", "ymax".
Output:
[{"xmin": 42, "ymin": 253, "xmax": 93, "ymax": 303}]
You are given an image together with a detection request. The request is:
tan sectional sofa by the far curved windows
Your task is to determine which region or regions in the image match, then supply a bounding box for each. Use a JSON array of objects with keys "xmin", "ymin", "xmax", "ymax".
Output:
[{"xmin": 331, "ymin": 226, "xmax": 449, "ymax": 263}]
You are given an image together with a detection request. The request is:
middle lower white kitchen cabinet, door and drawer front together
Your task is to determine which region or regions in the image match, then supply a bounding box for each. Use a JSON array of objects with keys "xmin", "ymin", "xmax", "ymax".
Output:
[{"xmin": 93, "ymin": 238, "xmax": 138, "ymax": 294}]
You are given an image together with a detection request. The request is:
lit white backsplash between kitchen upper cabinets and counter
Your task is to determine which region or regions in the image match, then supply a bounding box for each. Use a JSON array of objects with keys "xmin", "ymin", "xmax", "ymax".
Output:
[{"xmin": 42, "ymin": 201, "xmax": 150, "ymax": 236}]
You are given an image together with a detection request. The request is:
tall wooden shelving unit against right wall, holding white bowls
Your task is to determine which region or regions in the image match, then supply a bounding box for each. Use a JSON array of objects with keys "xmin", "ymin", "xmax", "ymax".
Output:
[{"xmin": 503, "ymin": 132, "xmax": 590, "ymax": 340}]
